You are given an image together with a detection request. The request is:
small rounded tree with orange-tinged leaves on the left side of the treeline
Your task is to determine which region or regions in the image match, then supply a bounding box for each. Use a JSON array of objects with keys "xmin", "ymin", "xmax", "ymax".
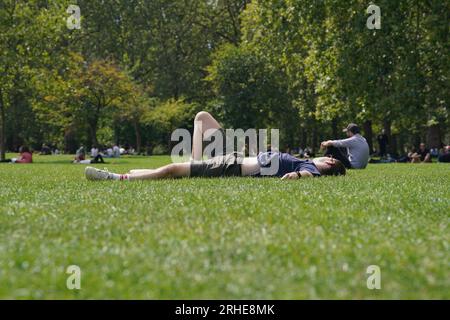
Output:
[{"xmin": 34, "ymin": 53, "xmax": 141, "ymax": 145}]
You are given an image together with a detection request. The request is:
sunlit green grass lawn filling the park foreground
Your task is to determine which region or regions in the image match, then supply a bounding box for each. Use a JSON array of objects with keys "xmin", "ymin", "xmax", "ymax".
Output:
[{"xmin": 0, "ymin": 156, "xmax": 450, "ymax": 299}]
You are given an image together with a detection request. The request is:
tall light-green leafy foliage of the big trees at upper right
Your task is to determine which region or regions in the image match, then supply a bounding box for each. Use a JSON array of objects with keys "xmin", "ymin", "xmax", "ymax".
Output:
[{"xmin": 237, "ymin": 0, "xmax": 450, "ymax": 147}]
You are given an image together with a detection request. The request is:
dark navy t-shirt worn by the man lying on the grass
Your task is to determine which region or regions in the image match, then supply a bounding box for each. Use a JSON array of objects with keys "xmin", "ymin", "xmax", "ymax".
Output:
[{"xmin": 258, "ymin": 152, "xmax": 320, "ymax": 177}]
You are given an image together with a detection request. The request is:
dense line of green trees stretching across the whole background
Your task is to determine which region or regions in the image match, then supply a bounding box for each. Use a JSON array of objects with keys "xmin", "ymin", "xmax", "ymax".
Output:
[{"xmin": 0, "ymin": 0, "xmax": 450, "ymax": 156}]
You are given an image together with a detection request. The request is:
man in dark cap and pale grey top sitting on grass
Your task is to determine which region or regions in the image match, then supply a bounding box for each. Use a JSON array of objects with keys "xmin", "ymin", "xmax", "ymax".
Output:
[{"xmin": 320, "ymin": 123, "xmax": 370, "ymax": 169}]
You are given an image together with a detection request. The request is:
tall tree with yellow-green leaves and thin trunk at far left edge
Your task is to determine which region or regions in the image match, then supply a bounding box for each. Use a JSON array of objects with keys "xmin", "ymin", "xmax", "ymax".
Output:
[{"xmin": 0, "ymin": 0, "xmax": 69, "ymax": 160}]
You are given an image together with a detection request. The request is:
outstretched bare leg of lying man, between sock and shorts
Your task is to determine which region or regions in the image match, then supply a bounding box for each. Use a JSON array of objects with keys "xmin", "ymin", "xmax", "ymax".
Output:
[{"xmin": 129, "ymin": 162, "xmax": 191, "ymax": 180}]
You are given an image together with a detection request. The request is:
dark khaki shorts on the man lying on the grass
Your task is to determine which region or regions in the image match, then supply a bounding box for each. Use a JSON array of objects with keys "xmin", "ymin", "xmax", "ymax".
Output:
[{"xmin": 190, "ymin": 152, "xmax": 243, "ymax": 177}]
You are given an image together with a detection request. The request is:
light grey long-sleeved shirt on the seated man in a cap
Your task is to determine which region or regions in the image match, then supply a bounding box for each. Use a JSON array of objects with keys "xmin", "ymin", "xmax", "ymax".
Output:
[{"xmin": 332, "ymin": 133, "xmax": 370, "ymax": 169}]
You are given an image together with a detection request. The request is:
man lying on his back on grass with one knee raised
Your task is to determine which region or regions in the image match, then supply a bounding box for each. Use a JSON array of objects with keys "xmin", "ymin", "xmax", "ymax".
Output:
[{"xmin": 85, "ymin": 112, "xmax": 345, "ymax": 180}]
